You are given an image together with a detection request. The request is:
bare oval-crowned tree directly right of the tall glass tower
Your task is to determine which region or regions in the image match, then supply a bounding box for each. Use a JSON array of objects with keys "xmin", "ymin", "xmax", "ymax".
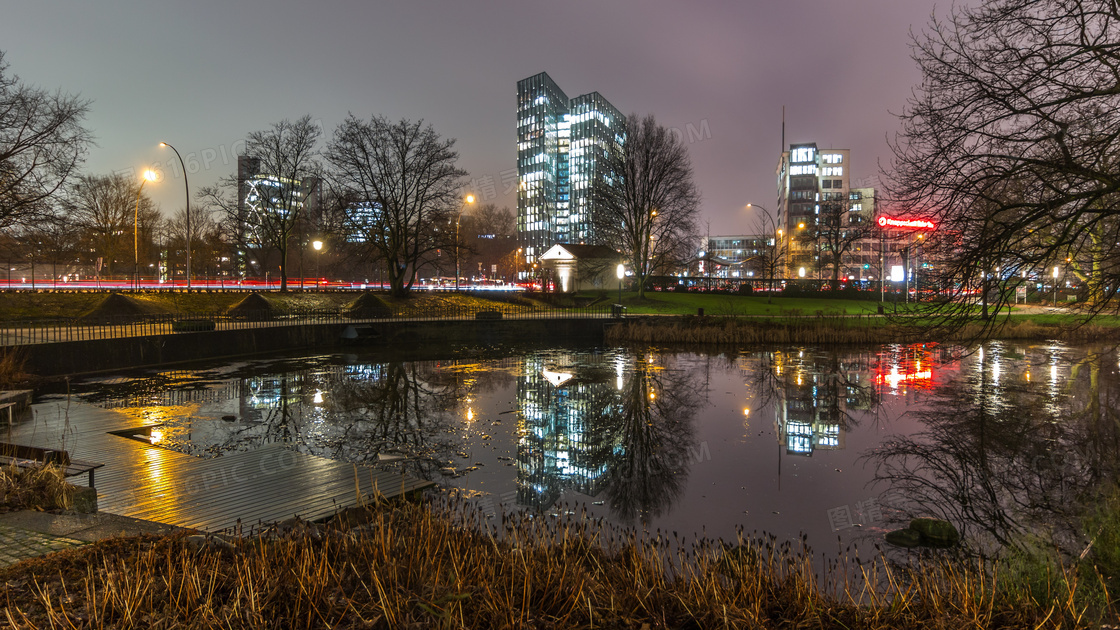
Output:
[{"xmin": 592, "ymin": 114, "xmax": 700, "ymax": 297}]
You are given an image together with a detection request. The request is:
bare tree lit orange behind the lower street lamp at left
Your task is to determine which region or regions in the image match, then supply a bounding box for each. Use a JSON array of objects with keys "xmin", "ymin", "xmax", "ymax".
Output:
[{"xmin": 65, "ymin": 174, "xmax": 160, "ymax": 274}]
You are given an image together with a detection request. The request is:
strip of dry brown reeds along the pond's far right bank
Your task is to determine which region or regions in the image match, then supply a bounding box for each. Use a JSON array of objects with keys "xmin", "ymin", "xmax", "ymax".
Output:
[{"xmin": 604, "ymin": 315, "xmax": 1120, "ymax": 345}]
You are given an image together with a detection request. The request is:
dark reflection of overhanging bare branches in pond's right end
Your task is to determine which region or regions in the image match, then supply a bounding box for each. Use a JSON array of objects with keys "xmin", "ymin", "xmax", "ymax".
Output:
[{"xmin": 866, "ymin": 345, "xmax": 1120, "ymax": 550}]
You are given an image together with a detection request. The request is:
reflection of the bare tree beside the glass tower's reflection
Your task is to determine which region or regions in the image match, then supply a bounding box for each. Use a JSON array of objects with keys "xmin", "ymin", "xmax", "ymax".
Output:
[{"xmin": 591, "ymin": 355, "xmax": 704, "ymax": 524}]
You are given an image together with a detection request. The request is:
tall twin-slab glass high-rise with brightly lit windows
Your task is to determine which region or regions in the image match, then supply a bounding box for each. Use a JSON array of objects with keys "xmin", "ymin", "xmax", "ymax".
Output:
[{"xmin": 517, "ymin": 72, "xmax": 626, "ymax": 263}]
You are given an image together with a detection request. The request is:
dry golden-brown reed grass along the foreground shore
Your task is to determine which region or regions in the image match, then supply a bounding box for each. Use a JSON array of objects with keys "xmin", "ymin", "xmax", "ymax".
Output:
[{"xmin": 0, "ymin": 495, "xmax": 1102, "ymax": 629}]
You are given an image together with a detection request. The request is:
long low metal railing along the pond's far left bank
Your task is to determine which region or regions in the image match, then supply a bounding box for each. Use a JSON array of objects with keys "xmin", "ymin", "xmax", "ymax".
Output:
[{"xmin": 0, "ymin": 305, "xmax": 615, "ymax": 348}]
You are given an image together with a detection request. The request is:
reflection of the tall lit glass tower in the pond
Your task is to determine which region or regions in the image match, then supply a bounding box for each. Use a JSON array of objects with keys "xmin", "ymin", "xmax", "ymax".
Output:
[{"xmin": 517, "ymin": 349, "xmax": 615, "ymax": 508}]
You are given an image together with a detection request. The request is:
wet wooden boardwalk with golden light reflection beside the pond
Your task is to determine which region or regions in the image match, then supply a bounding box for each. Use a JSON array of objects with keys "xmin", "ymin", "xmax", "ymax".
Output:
[{"xmin": 8, "ymin": 401, "xmax": 432, "ymax": 531}]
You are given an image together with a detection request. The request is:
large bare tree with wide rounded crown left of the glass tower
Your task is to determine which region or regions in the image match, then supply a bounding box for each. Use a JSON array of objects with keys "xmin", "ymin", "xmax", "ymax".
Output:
[{"xmin": 327, "ymin": 115, "xmax": 466, "ymax": 296}]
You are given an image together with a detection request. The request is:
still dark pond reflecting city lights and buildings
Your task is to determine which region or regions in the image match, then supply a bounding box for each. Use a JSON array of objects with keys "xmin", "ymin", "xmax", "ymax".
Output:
[{"xmin": 45, "ymin": 342, "xmax": 1120, "ymax": 550}]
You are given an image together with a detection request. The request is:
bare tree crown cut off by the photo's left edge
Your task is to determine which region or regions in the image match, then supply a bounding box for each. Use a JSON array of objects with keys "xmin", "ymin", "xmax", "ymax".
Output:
[{"xmin": 0, "ymin": 52, "xmax": 91, "ymax": 228}]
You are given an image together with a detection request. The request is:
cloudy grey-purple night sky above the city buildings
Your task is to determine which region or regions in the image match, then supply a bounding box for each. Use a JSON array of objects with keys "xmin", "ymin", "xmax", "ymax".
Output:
[{"xmin": 0, "ymin": 0, "xmax": 948, "ymax": 235}]
